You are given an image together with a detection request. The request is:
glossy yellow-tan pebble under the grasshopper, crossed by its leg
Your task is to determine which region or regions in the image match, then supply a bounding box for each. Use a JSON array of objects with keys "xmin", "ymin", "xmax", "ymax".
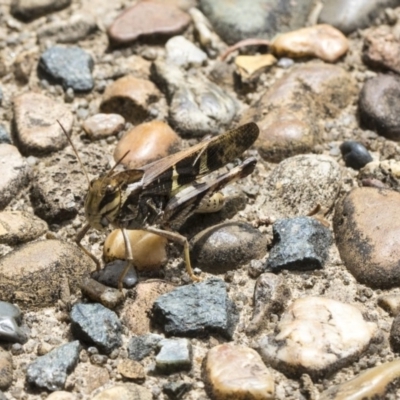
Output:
[{"xmin": 103, "ymin": 229, "xmax": 167, "ymax": 271}]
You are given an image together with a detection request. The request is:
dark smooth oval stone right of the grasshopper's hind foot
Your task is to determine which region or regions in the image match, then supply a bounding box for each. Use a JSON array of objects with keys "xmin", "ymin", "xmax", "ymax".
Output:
[{"xmin": 190, "ymin": 222, "xmax": 267, "ymax": 273}]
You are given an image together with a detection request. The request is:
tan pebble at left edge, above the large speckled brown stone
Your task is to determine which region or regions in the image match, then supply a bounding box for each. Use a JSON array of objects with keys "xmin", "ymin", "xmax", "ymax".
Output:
[{"xmin": 0, "ymin": 211, "xmax": 47, "ymax": 245}]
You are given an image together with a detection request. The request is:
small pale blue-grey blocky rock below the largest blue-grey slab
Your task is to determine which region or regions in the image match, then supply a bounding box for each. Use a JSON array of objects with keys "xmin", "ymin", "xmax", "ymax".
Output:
[{"xmin": 156, "ymin": 339, "xmax": 192, "ymax": 374}]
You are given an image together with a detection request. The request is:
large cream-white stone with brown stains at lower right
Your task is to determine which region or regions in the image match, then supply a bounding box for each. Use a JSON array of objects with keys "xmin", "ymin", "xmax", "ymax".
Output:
[{"xmin": 258, "ymin": 297, "xmax": 377, "ymax": 379}]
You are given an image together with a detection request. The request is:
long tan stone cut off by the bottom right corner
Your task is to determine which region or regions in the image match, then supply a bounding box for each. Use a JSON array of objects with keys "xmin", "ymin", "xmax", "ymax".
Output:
[{"xmin": 319, "ymin": 360, "xmax": 400, "ymax": 400}]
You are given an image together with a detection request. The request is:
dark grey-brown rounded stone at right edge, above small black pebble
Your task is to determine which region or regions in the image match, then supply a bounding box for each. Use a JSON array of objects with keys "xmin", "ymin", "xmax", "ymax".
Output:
[{"xmin": 359, "ymin": 75, "xmax": 400, "ymax": 141}]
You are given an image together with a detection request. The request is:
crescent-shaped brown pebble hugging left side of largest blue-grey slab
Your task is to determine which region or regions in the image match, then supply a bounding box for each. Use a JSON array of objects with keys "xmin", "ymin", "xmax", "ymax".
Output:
[{"xmin": 122, "ymin": 280, "xmax": 175, "ymax": 335}]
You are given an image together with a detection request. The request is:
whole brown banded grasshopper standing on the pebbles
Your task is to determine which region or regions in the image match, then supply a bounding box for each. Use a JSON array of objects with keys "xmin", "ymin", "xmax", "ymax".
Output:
[{"xmin": 61, "ymin": 122, "xmax": 259, "ymax": 290}]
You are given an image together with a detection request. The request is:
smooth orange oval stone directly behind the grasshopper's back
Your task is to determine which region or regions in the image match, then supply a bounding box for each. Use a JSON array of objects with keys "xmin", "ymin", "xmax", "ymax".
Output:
[{"xmin": 114, "ymin": 121, "xmax": 181, "ymax": 169}]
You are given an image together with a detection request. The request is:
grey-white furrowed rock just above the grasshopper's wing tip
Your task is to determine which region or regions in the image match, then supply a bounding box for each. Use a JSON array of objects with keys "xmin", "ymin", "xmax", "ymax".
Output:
[{"xmin": 152, "ymin": 61, "xmax": 237, "ymax": 137}]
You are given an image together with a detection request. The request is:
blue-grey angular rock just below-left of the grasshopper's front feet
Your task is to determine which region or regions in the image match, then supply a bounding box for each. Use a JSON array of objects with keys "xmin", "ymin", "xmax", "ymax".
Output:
[{"xmin": 70, "ymin": 304, "xmax": 122, "ymax": 354}]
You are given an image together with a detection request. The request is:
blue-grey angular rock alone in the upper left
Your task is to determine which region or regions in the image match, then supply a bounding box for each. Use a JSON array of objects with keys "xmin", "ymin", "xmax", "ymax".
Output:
[{"xmin": 39, "ymin": 46, "xmax": 94, "ymax": 92}]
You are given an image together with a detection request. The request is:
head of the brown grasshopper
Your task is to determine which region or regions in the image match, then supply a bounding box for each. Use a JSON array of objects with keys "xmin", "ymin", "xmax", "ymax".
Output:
[{"xmin": 85, "ymin": 176, "xmax": 121, "ymax": 230}]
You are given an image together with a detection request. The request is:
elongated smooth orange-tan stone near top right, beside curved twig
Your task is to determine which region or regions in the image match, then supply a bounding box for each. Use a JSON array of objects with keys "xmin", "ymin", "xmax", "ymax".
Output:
[{"xmin": 271, "ymin": 24, "xmax": 349, "ymax": 62}]
